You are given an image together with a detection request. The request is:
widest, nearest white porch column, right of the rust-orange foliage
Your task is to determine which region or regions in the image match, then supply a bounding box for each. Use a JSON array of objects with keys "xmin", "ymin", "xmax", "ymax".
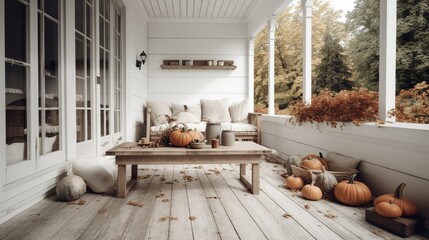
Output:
[{"xmin": 378, "ymin": 0, "xmax": 396, "ymax": 122}]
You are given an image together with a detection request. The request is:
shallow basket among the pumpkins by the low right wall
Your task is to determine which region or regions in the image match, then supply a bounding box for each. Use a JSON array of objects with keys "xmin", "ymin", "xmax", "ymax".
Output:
[{"xmin": 291, "ymin": 165, "xmax": 359, "ymax": 183}]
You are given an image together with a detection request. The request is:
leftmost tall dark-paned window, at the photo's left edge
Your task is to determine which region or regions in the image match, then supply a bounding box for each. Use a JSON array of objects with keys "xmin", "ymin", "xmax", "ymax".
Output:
[{"xmin": 4, "ymin": 0, "xmax": 30, "ymax": 165}]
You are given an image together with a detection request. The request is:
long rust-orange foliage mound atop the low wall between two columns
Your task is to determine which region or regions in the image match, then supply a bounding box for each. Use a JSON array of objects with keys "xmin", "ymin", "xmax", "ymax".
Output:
[{"xmin": 291, "ymin": 88, "xmax": 378, "ymax": 128}]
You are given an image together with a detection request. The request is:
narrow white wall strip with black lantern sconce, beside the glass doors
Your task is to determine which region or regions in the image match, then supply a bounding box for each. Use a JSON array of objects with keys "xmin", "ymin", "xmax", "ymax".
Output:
[{"xmin": 124, "ymin": 1, "xmax": 148, "ymax": 141}]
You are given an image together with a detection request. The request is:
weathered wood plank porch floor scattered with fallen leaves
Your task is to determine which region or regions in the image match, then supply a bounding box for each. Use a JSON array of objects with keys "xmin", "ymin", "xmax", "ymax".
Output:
[{"xmin": 0, "ymin": 163, "xmax": 424, "ymax": 240}]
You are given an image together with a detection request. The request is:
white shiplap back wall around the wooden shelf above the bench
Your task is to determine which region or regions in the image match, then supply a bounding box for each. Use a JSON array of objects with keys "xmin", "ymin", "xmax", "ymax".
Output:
[{"xmin": 148, "ymin": 22, "xmax": 248, "ymax": 104}]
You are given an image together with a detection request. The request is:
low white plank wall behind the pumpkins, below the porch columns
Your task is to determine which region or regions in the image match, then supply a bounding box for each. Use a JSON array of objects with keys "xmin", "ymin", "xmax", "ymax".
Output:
[{"xmin": 262, "ymin": 116, "xmax": 429, "ymax": 218}]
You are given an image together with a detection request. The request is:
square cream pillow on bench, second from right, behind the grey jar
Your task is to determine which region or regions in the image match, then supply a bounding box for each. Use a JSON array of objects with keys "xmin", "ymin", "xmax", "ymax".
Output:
[{"xmin": 200, "ymin": 98, "xmax": 231, "ymax": 122}]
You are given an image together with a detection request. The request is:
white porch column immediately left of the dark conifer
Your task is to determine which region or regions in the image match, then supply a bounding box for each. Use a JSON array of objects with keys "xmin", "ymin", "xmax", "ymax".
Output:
[{"xmin": 301, "ymin": 0, "xmax": 313, "ymax": 103}]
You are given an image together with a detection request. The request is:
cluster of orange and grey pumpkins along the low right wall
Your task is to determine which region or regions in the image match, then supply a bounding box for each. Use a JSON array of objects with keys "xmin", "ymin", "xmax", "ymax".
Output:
[{"xmin": 284, "ymin": 154, "xmax": 418, "ymax": 218}]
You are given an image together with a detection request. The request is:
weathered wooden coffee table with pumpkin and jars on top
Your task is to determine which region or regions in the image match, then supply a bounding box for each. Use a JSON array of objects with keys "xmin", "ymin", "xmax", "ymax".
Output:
[{"xmin": 106, "ymin": 141, "xmax": 271, "ymax": 198}]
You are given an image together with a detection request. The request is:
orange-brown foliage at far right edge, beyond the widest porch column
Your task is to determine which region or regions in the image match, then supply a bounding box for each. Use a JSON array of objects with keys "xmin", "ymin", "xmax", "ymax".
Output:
[{"xmin": 391, "ymin": 82, "xmax": 429, "ymax": 123}]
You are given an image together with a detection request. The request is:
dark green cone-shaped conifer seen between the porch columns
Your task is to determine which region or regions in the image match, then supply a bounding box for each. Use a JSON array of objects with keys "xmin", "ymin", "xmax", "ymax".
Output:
[{"xmin": 312, "ymin": 31, "xmax": 353, "ymax": 93}]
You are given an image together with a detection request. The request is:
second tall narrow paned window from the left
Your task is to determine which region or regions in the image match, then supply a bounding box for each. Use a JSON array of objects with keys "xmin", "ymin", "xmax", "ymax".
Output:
[{"xmin": 37, "ymin": 0, "xmax": 61, "ymax": 155}]
